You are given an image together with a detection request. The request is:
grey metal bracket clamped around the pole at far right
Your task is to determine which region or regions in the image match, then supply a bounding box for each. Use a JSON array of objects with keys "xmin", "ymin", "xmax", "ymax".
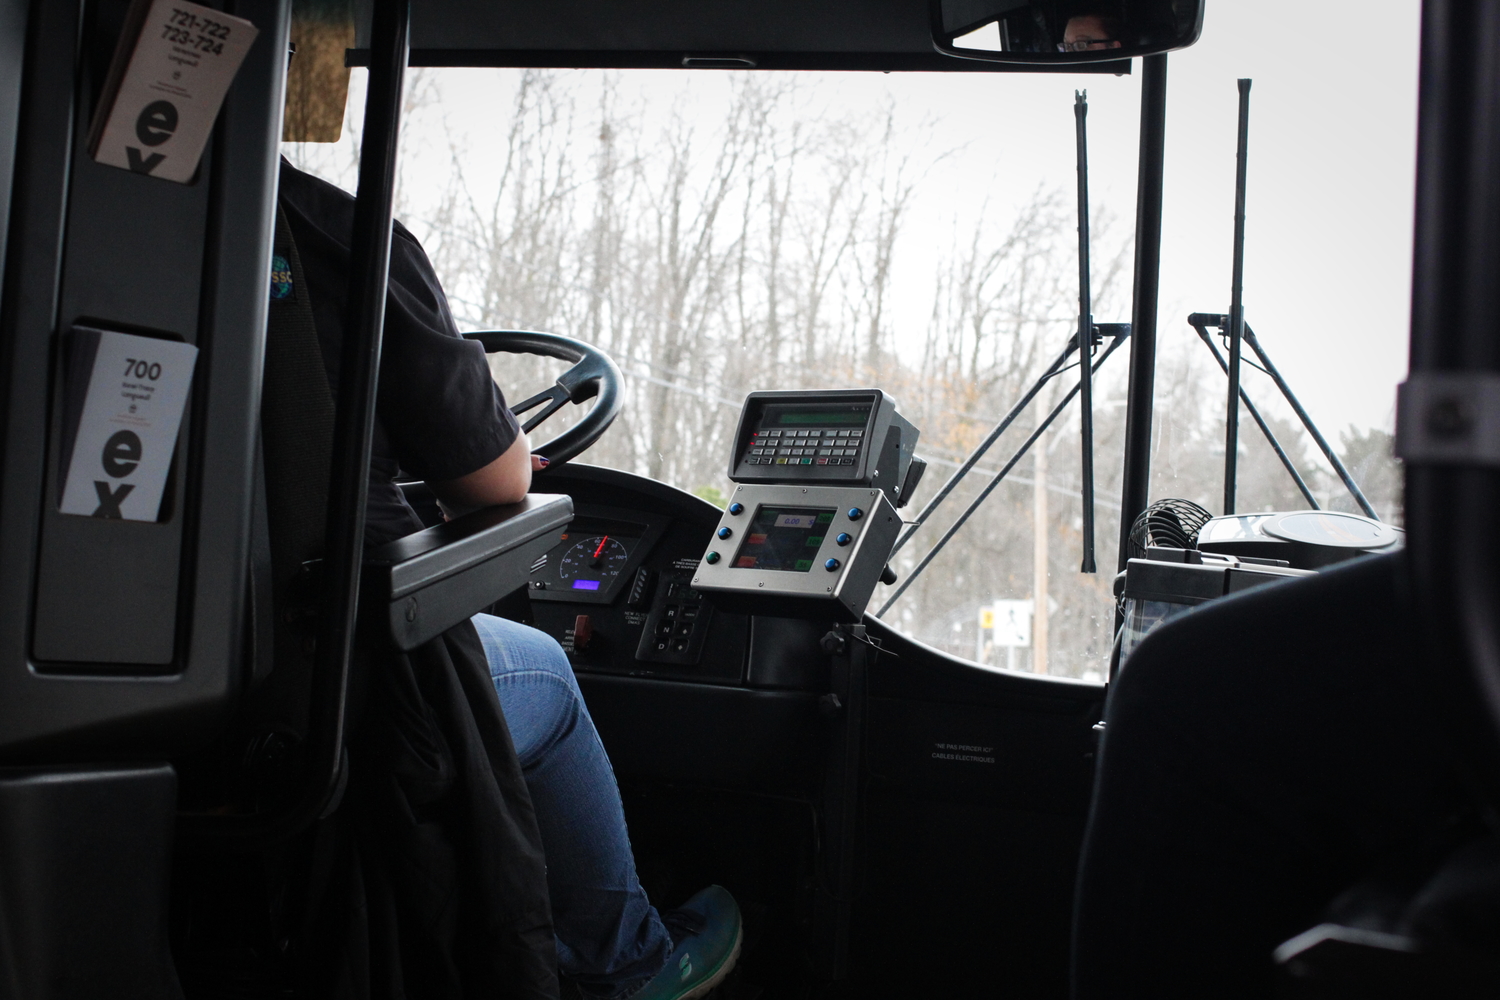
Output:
[{"xmin": 1397, "ymin": 372, "xmax": 1500, "ymax": 468}]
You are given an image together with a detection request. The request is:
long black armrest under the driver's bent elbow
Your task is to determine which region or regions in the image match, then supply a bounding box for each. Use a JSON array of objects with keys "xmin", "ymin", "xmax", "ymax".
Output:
[{"xmin": 365, "ymin": 493, "xmax": 573, "ymax": 651}]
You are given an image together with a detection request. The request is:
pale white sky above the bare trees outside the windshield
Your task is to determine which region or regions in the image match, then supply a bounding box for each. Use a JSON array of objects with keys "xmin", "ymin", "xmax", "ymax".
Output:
[{"xmin": 322, "ymin": 0, "xmax": 1419, "ymax": 441}]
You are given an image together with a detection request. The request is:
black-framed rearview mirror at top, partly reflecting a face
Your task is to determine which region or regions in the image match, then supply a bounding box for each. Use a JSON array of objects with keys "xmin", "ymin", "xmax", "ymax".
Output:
[{"xmin": 933, "ymin": 0, "xmax": 1203, "ymax": 63}]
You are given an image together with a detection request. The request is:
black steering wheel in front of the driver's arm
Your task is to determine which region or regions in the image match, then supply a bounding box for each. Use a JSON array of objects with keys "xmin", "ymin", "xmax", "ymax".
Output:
[{"xmin": 464, "ymin": 330, "xmax": 621, "ymax": 465}]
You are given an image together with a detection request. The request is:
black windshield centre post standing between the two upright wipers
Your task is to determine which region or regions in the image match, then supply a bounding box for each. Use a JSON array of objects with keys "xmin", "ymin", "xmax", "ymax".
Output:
[{"xmin": 1119, "ymin": 55, "xmax": 1167, "ymax": 570}]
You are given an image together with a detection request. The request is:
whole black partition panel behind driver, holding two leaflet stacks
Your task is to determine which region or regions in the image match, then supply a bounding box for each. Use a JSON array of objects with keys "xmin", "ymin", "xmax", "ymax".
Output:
[{"xmin": 0, "ymin": 0, "xmax": 290, "ymax": 760}]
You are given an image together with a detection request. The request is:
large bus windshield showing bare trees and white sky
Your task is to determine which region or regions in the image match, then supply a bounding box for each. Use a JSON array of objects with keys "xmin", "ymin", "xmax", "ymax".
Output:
[{"xmin": 287, "ymin": 12, "xmax": 1416, "ymax": 679}]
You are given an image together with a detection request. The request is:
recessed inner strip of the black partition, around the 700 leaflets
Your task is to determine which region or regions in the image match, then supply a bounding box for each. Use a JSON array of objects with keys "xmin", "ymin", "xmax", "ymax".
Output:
[{"xmin": 32, "ymin": 83, "xmax": 213, "ymax": 672}]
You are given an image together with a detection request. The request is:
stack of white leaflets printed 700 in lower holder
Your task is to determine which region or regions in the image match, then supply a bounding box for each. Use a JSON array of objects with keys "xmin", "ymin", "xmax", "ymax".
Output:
[{"xmin": 60, "ymin": 327, "xmax": 198, "ymax": 520}]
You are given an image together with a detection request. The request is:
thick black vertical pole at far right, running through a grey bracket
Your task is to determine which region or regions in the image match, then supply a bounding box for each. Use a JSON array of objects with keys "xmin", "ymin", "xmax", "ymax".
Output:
[{"xmin": 1401, "ymin": 0, "xmax": 1500, "ymax": 785}]
